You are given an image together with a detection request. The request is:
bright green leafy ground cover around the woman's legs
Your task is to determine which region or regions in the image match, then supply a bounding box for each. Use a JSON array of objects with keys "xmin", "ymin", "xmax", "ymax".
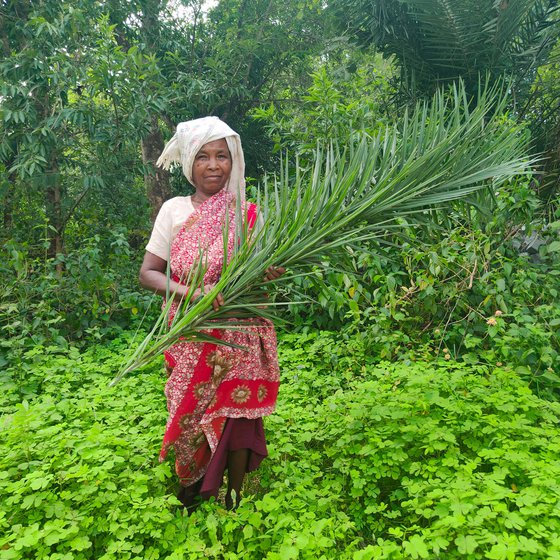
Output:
[{"xmin": 0, "ymin": 332, "xmax": 560, "ymax": 560}]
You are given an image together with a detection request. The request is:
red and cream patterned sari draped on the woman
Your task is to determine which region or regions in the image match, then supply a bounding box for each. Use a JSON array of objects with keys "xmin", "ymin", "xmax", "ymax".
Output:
[{"xmin": 160, "ymin": 190, "xmax": 279, "ymax": 486}]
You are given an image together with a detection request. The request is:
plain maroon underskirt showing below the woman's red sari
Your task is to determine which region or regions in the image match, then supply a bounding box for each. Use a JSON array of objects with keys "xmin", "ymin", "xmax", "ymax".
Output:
[{"xmin": 200, "ymin": 418, "xmax": 268, "ymax": 499}]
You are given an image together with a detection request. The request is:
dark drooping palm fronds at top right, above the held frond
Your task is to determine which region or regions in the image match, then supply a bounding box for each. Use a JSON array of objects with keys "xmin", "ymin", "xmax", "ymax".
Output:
[{"xmin": 331, "ymin": 0, "xmax": 559, "ymax": 95}]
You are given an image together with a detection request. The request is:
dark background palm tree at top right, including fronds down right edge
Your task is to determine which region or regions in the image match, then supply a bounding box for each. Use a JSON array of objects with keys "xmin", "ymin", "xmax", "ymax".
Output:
[{"xmin": 330, "ymin": 0, "xmax": 560, "ymax": 200}]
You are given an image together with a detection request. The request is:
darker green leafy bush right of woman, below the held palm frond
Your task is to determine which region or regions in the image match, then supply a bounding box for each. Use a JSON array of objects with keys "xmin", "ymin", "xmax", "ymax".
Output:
[{"xmin": 282, "ymin": 212, "xmax": 560, "ymax": 399}]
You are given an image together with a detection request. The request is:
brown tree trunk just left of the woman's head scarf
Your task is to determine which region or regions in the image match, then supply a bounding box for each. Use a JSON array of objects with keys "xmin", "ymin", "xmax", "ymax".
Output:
[{"xmin": 142, "ymin": 117, "xmax": 171, "ymax": 220}]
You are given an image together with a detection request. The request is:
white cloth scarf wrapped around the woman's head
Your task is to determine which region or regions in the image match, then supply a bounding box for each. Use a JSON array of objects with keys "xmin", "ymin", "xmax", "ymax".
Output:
[{"xmin": 156, "ymin": 117, "xmax": 245, "ymax": 200}]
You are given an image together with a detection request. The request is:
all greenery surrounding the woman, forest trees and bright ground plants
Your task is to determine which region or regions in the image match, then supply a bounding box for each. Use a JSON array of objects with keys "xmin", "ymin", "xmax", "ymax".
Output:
[{"xmin": 0, "ymin": 0, "xmax": 560, "ymax": 559}]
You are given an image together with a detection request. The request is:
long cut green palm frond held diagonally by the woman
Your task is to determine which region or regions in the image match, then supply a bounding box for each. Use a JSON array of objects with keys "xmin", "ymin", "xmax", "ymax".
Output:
[{"xmin": 112, "ymin": 81, "xmax": 531, "ymax": 379}]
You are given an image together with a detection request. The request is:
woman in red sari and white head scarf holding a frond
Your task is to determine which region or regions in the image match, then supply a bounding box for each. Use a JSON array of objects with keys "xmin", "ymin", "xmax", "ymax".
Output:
[{"xmin": 140, "ymin": 117, "xmax": 283, "ymax": 509}]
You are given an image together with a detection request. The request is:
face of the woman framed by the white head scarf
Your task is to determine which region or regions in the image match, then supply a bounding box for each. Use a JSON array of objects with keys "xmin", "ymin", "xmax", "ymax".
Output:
[{"xmin": 192, "ymin": 138, "xmax": 231, "ymax": 198}]
